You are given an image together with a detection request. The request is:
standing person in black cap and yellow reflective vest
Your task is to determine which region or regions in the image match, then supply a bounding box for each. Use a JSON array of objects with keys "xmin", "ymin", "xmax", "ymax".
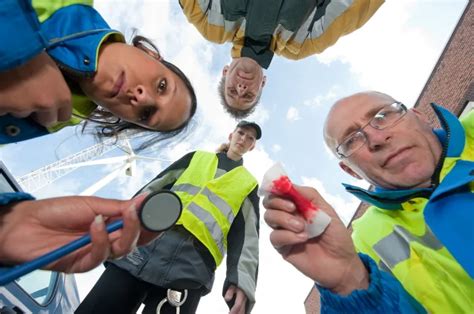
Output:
[{"xmin": 76, "ymin": 121, "xmax": 262, "ymax": 314}]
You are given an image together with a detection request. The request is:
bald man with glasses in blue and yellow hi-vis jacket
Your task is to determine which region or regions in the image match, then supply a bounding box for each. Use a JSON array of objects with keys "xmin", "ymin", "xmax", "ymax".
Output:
[{"xmin": 264, "ymin": 92, "xmax": 474, "ymax": 313}]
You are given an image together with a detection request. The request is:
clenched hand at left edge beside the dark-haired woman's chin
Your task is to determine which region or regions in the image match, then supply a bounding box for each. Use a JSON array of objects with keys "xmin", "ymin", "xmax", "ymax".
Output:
[{"xmin": 0, "ymin": 52, "xmax": 72, "ymax": 127}]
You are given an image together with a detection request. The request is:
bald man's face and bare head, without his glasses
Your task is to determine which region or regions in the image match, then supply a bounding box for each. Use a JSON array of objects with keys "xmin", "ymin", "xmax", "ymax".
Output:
[{"xmin": 325, "ymin": 93, "xmax": 442, "ymax": 189}]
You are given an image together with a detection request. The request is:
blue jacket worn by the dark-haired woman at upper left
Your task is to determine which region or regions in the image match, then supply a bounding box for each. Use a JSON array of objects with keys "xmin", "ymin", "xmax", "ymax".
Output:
[{"xmin": 0, "ymin": 0, "xmax": 124, "ymax": 144}]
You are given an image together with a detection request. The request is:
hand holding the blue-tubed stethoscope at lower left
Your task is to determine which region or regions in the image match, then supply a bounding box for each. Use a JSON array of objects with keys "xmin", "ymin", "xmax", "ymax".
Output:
[{"xmin": 0, "ymin": 195, "xmax": 159, "ymax": 272}]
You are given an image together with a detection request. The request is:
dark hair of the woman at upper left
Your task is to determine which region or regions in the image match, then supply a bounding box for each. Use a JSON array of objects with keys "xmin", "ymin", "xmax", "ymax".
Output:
[{"xmin": 81, "ymin": 36, "xmax": 197, "ymax": 150}]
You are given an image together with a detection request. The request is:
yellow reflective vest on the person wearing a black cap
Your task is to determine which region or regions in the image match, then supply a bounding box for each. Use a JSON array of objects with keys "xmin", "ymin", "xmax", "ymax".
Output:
[{"xmin": 172, "ymin": 151, "xmax": 257, "ymax": 266}]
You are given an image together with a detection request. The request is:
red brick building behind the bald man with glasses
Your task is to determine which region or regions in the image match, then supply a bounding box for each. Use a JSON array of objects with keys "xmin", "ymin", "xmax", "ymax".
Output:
[{"xmin": 305, "ymin": 1, "xmax": 474, "ymax": 314}]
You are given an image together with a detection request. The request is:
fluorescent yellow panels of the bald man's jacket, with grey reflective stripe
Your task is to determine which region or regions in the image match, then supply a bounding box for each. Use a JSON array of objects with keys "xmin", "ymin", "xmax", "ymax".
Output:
[{"xmin": 353, "ymin": 134, "xmax": 474, "ymax": 313}]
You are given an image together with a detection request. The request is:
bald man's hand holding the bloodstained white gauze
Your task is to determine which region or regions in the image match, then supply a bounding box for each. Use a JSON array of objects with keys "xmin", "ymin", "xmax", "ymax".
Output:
[{"xmin": 263, "ymin": 186, "xmax": 368, "ymax": 295}]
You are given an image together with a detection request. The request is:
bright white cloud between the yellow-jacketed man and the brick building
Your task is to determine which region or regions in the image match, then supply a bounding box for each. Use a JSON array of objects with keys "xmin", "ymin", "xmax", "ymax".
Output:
[{"xmin": 317, "ymin": 0, "xmax": 450, "ymax": 104}]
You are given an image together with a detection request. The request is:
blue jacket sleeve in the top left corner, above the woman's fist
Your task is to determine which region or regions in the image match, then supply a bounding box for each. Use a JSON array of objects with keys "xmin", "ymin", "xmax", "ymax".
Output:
[{"xmin": 0, "ymin": 0, "xmax": 47, "ymax": 71}]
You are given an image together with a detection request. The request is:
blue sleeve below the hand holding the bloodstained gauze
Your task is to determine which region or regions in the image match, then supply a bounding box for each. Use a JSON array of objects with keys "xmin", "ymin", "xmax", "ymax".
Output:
[{"xmin": 316, "ymin": 254, "xmax": 427, "ymax": 314}]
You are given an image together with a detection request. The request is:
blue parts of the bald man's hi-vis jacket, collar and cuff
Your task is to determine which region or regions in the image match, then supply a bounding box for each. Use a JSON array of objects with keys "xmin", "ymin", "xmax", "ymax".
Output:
[{"xmin": 318, "ymin": 104, "xmax": 474, "ymax": 313}]
